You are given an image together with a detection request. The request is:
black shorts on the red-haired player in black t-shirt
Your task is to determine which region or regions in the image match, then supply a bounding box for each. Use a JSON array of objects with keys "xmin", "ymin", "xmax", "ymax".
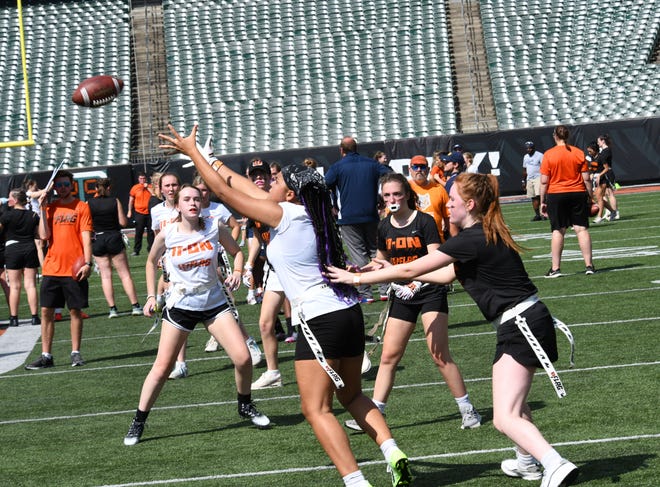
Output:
[{"xmin": 493, "ymin": 301, "xmax": 558, "ymax": 367}]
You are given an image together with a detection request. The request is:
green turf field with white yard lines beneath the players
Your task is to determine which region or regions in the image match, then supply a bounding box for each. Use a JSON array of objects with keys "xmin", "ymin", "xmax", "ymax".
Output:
[{"xmin": 0, "ymin": 193, "xmax": 660, "ymax": 487}]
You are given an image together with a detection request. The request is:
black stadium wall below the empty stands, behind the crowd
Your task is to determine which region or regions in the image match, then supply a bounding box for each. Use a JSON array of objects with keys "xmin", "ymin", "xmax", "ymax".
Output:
[{"xmin": 0, "ymin": 117, "xmax": 660, "ymax": 207}]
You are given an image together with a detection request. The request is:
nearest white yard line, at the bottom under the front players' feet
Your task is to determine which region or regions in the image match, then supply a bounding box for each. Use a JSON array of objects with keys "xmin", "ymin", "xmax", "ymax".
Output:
[{"xmin": 94, "ymin": 433, "xmax": 660, "ymax": 487}]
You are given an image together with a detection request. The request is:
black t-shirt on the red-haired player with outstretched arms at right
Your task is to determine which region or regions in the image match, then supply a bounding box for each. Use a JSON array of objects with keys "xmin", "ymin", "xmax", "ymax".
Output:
[{"xmin": 439, "ymin": 223, "xmax": 538, "ymax": 321}]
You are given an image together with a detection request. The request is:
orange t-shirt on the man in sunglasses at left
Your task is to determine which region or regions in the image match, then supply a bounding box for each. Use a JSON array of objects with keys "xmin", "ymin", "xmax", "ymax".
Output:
[{"xmin": 43, "ymin": 199, "xmax": 92, "ymax": 277}]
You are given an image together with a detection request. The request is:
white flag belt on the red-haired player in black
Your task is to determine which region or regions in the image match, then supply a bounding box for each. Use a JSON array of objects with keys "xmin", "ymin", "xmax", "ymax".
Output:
[{"xmin": 493, "ymin": 295, "xmax": 575, "ymax": 398}]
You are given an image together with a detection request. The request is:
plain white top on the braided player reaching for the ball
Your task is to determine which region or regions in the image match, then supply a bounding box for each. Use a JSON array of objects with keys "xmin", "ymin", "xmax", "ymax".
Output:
[{"xmin": 266, "ymin": 203, "xmax": 357, "ymax": 320}]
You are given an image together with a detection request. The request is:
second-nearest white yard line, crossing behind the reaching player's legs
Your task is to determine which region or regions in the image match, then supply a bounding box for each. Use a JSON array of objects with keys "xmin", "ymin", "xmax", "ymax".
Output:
[{"xmin": 0, "ymin": 360, "xmax": 660, "ymax": 426}]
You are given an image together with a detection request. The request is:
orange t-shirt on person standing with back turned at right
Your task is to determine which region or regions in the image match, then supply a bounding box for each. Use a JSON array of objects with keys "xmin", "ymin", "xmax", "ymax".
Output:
[{"xmin": 541, "ymin": 145, "xmax": 589, "ymax": 194}]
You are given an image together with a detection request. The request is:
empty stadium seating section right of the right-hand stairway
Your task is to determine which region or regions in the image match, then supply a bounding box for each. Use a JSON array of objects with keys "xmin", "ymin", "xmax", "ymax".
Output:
[{"xmin": 480, "ymin": 0, "xmax": 660, "ymax": 129}]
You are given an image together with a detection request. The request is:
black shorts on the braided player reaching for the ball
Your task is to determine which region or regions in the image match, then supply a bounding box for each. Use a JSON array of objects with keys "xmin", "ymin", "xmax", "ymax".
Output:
[{"xmin": 295, "ymin": 304, "xmax": 364, "ymax": 360}]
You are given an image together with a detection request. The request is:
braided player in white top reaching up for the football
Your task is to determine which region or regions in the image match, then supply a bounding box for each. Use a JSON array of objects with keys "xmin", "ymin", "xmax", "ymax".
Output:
[{"xmin": 159, "ymin": 125, "xmax": 412, "ymax": 486}]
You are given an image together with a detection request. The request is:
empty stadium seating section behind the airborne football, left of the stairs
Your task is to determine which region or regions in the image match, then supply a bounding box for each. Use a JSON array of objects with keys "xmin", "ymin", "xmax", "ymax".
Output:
[{"xmin": 0, "ymin": 0, "xmax": 131, "ymax": 174}]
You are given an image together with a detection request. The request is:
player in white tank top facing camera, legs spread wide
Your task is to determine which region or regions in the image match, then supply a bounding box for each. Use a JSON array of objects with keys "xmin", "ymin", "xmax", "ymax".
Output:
[{"xmin": 124, "ymin": 185, "xmax": 270, "ymax": 445}]
